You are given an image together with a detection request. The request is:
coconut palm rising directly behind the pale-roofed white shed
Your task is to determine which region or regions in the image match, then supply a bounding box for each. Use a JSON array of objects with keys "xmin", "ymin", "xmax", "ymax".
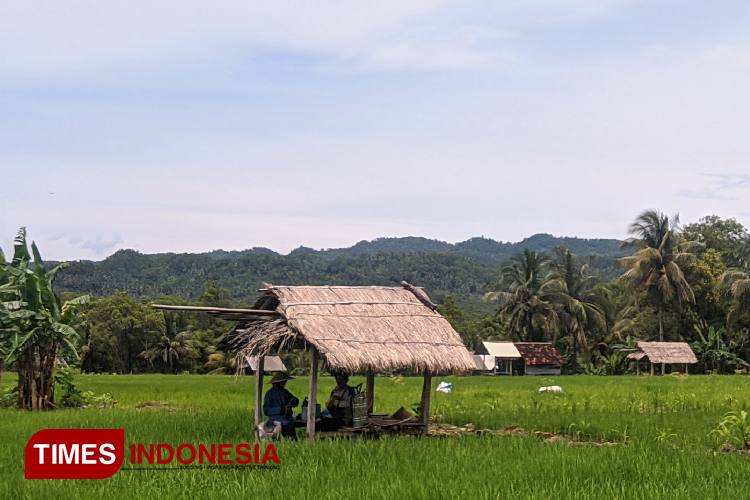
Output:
[{"xmin": 485, "ymin": 250, "xmax": 559, "ymax": 342}]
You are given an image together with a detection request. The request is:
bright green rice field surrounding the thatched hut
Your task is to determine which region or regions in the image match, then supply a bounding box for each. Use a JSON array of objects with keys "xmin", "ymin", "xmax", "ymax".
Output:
[{"xmin": 0, "ymin": 374, "xmax": 750, "ymax": 499}]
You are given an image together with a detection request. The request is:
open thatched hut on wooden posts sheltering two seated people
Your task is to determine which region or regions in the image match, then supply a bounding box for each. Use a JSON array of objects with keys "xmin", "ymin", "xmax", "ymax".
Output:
[{"xmin": 163, "ymin": 282, "xmax": 476, "ymax": 437}]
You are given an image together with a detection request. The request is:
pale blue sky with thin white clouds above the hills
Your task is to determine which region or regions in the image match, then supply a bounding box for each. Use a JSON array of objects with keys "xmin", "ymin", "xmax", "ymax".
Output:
[{"xmin": 0, "ymin": 0, "xmax": 750, "ymax": 260}]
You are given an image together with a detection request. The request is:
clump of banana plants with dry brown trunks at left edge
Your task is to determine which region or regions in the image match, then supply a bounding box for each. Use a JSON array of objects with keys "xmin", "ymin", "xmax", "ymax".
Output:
[{"xmin": 0, "ymin": 228, "xmax": 89, "ymax": 409}]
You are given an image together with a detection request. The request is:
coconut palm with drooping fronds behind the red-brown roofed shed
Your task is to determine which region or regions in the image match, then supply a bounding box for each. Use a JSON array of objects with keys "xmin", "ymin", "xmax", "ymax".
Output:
[{"xmin": 545, "ymin": 248, "xmax": 608, "ymax": 363}]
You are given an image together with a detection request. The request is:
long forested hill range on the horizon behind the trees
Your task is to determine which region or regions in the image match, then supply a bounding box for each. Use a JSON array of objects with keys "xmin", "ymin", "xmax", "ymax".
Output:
[{"xmin": 58, "ymin": 234, "xmax": 622, "ymax": 302}]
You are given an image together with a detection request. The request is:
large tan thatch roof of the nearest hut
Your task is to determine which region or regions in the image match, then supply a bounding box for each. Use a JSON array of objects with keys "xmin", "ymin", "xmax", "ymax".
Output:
[{"xmin": 236, "ymin": 284, "xmax": 476, "ymax": 373}]
